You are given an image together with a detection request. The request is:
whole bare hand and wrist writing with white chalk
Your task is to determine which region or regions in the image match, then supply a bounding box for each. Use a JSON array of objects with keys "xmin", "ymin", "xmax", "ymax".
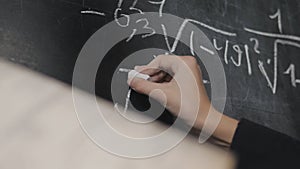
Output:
[{"xmin": 127, "ymin": 55, "xmax": 238, "ymax": 143}]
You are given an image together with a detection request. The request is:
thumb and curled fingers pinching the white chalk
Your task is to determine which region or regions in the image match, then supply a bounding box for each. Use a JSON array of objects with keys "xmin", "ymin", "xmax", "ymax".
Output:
[{"xmin": 128, "ymin": 55, "xmax": 199, "ymax": 95}]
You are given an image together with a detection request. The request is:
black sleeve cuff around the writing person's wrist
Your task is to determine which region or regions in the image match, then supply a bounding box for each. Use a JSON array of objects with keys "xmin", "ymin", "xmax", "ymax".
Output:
[{"xmin": 231, "ymin": 119, "xmax": 300, "ymax": 169}]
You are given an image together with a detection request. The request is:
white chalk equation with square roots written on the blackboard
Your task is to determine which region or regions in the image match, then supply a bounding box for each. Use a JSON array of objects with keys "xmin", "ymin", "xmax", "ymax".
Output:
[{"xmin": 81, "ymin": 0, "xmax": 300, "ymax": 94}]
